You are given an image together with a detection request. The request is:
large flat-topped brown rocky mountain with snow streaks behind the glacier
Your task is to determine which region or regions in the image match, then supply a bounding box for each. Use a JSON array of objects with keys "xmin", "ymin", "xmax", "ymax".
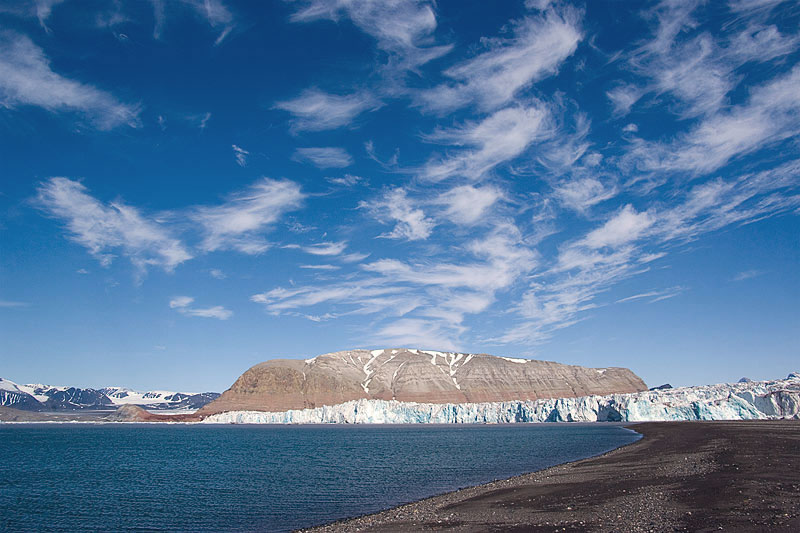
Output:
[{"xmin": 197, "ymin": 349, "xmax": 647, "ymax": 416}]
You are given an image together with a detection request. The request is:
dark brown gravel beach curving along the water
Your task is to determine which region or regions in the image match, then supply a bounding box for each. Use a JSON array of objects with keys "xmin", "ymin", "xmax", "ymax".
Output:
[{"xmin": 300, "ymin": 420, "xmax": 800, "ymax": 532}]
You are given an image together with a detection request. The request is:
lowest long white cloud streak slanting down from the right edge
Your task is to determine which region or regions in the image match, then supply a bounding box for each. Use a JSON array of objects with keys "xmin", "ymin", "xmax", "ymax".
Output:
[{"xmin": 496, "ymin": 160, "xmax": 800, "ymax": 343}]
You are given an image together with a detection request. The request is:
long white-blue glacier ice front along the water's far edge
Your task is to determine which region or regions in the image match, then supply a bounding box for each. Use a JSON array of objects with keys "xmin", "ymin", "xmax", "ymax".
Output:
[{"xmin": 203, "ymin": 373, "xmax": 800, "ymax": 424}]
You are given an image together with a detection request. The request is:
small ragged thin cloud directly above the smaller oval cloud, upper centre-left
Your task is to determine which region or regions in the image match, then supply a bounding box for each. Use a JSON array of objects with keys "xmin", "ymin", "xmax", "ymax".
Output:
[{"xmin": 274, "ymin": 89, "xmax": 382, "ymax": 133}]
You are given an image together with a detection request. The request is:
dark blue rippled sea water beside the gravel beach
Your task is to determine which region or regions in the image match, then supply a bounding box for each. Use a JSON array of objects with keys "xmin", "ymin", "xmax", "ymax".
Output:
[{"xmin": 0, "ymin": 424, "xmax": 638, "ymax": 532}]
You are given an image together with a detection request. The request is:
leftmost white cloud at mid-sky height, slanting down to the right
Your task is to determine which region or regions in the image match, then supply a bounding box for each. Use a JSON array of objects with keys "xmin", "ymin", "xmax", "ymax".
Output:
[{"xmin": 35, "ymin": 178, "xmax": 193, "ymax": 274}]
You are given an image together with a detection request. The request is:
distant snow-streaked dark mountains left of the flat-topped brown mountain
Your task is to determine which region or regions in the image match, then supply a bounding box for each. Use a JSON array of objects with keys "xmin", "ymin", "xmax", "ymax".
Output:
[{"xmin": 0, "ymin": 378, "xmax": 219, "ymax": 411}]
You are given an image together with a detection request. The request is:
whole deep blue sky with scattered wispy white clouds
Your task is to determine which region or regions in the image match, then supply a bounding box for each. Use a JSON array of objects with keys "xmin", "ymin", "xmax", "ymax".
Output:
[{"xmin": 0, "ymin": 0, "xmax": 800, "ymax": 390}]
